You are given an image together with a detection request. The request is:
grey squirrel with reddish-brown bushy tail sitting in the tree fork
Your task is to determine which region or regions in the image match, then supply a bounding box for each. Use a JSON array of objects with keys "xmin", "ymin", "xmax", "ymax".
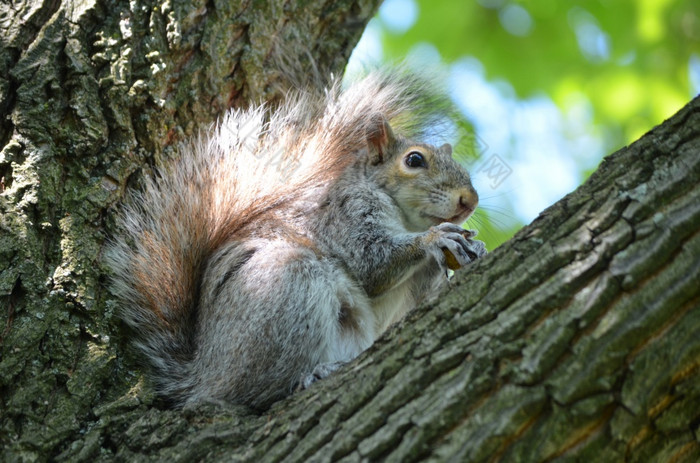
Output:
[{"xmin": 107, "ymin": 73, "xmax": 486, "ymax": 409}]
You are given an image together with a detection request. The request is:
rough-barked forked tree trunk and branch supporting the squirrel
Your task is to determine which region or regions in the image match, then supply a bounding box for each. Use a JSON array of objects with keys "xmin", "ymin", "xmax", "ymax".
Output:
[{"xmin": 0, "ymin": 0, "xmax": 700, "ymax": 462}]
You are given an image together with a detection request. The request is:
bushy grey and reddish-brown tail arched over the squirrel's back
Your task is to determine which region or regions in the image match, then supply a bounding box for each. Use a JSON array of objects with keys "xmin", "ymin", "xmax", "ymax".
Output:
[{"xmin": 108, "ymin": 72, "xmax": 454, "ymax": 403}]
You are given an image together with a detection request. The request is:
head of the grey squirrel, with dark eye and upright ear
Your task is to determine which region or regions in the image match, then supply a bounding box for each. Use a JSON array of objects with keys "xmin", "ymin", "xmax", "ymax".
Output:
[{"xmin": 367, "ymin": 116, "xmax": 479, "ymax": 231}]
